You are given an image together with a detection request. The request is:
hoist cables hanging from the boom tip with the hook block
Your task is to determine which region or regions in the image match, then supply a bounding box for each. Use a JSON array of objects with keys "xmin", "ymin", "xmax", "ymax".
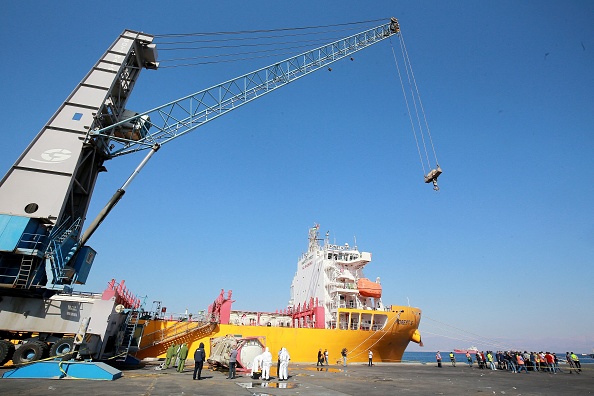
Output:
[{"xmin": 390, "ymin": 30, "xmax": 441, "ymax": 191}]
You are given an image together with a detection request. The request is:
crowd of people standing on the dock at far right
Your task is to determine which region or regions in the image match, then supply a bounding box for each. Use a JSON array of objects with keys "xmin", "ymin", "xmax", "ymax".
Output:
[{"xmin": 446, "ymin": 351, "xmax": 582, "ymax": 374}]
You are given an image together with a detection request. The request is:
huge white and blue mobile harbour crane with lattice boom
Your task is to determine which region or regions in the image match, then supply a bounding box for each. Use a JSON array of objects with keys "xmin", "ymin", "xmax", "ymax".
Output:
[{"xmin": 0, "ymin": 18, "xmax": 441, "ymax": 372}]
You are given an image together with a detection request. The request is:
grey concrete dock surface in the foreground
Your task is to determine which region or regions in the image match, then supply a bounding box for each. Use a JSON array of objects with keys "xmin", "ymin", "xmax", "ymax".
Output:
[{"xmin": 0, "ymin": 361, "xmax": 594, "ymax": 396}]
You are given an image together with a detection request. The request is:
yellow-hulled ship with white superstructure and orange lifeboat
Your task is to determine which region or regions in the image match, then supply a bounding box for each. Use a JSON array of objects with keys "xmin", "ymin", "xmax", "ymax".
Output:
[{"xmin": 135, "ymin": 224, "xmax": 422, "ymax": 364}]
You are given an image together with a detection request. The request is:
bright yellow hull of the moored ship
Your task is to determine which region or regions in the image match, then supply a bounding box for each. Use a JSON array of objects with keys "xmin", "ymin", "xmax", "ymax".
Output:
[{"xmin": 136, "ymin": 306, "xmax": 421, "ymax": 364}]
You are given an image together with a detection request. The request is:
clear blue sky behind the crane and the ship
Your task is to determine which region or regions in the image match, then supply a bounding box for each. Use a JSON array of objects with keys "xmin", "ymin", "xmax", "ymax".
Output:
[{"xmin": 0, "ymin": 0, "xmax": 594, "ymax": 352}]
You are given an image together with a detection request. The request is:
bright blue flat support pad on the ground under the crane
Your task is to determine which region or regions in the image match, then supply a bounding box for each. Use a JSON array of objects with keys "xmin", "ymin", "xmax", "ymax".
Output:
[{"xmin": 2, "ymin": 360, "xmax": 122, "ymax": 381}]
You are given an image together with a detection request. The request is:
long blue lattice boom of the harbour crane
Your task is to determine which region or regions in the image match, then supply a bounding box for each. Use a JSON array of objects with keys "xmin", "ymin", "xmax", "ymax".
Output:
[{"xmin": 89, "ymin": 18, "xmax": 400, "ymax": 157}]
